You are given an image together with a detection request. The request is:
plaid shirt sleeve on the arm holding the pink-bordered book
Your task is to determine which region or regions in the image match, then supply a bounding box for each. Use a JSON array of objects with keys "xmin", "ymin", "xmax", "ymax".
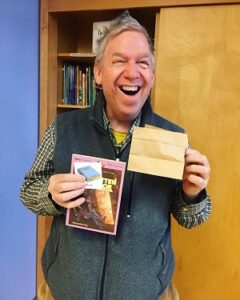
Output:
[{"xmin": 20, "ymin": 122, "xmax": 61, "ymax": 216}]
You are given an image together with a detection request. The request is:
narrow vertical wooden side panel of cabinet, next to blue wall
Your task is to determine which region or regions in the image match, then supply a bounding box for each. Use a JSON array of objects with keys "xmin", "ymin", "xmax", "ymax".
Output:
[{"xmin": 37, "ymin": 1, "xmax": 57, "ymax": 290}]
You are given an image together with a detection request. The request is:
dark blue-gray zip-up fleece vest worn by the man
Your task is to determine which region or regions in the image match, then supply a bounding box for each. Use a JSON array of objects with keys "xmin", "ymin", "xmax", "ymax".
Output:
[{"xmin": 42, "ymin": 94, "xmax": 182, "ymax": 300}]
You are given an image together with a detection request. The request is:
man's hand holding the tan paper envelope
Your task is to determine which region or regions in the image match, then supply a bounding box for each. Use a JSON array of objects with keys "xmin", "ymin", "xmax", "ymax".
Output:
[{"xmin": 182, "ymin": 148, "xmax": 210, "ymax": 199}]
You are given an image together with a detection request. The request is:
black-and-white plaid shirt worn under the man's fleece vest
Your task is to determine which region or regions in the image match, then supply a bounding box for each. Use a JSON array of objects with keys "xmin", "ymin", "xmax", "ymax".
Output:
[{"xmin": 20, "ymin": 111, "xmax": 211, "ymax": 228}]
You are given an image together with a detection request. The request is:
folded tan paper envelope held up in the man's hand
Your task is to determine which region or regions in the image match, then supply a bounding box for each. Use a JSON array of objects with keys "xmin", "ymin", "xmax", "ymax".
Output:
[{"xmin": 127, "ymin": 125, "xmax": 188, "ymax": 179}]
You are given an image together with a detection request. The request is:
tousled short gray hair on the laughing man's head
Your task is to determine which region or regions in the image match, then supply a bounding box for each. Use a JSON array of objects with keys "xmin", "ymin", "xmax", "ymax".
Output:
[{"xmin": 95, "ymin": 11, "xmax": 154, "ymax": 66}]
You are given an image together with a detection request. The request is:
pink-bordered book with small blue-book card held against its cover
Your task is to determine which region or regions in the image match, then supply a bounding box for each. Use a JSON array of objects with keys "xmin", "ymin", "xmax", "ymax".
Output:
[{"xmin": 66, "ymin": 154, "xmax": 126, "ymax": 235}]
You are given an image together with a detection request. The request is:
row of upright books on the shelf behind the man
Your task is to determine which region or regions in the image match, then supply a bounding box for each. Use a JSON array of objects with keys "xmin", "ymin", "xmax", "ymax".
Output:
[{"xmin": 62, "ymin": 63, "xmax": 96, "ymax": 106}]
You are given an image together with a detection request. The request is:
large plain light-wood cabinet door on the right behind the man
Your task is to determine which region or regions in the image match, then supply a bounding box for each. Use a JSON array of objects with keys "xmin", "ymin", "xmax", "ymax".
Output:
[{"xmin": 153, "ymin": 5, "xmax": 240, "ymax": 300}]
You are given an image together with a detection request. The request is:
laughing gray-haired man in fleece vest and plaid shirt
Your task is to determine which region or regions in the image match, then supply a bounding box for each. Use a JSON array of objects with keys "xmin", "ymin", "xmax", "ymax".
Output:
[{"xmin": 21, "ymin": 13, "xmax": 211, "ymax": 300}]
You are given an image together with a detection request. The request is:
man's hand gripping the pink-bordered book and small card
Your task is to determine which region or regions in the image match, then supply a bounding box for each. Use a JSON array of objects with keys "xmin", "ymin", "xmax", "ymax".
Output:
[{"xmin": 48, "ymin": 174, "xmax": 86, "ymax": 208}]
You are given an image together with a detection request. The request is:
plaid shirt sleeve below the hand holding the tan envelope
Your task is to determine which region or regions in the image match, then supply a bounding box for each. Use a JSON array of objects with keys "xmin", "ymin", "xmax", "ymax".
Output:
[{"xmin": 172, "ymin": 183, "xmax": 212, "ymax": 229}]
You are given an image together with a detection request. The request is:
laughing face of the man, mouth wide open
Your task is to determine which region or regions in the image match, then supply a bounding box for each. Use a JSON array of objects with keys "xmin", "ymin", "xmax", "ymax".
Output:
[{"xmin": 94, "ymin": 31, "xmax": 154, "ymax": 130}]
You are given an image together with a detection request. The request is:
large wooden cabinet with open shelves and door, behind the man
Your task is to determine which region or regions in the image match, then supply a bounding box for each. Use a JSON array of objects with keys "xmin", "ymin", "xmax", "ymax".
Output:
[{"xmin": 37, "ymin": 0, "xmax": 240, "ymax": 300}]
